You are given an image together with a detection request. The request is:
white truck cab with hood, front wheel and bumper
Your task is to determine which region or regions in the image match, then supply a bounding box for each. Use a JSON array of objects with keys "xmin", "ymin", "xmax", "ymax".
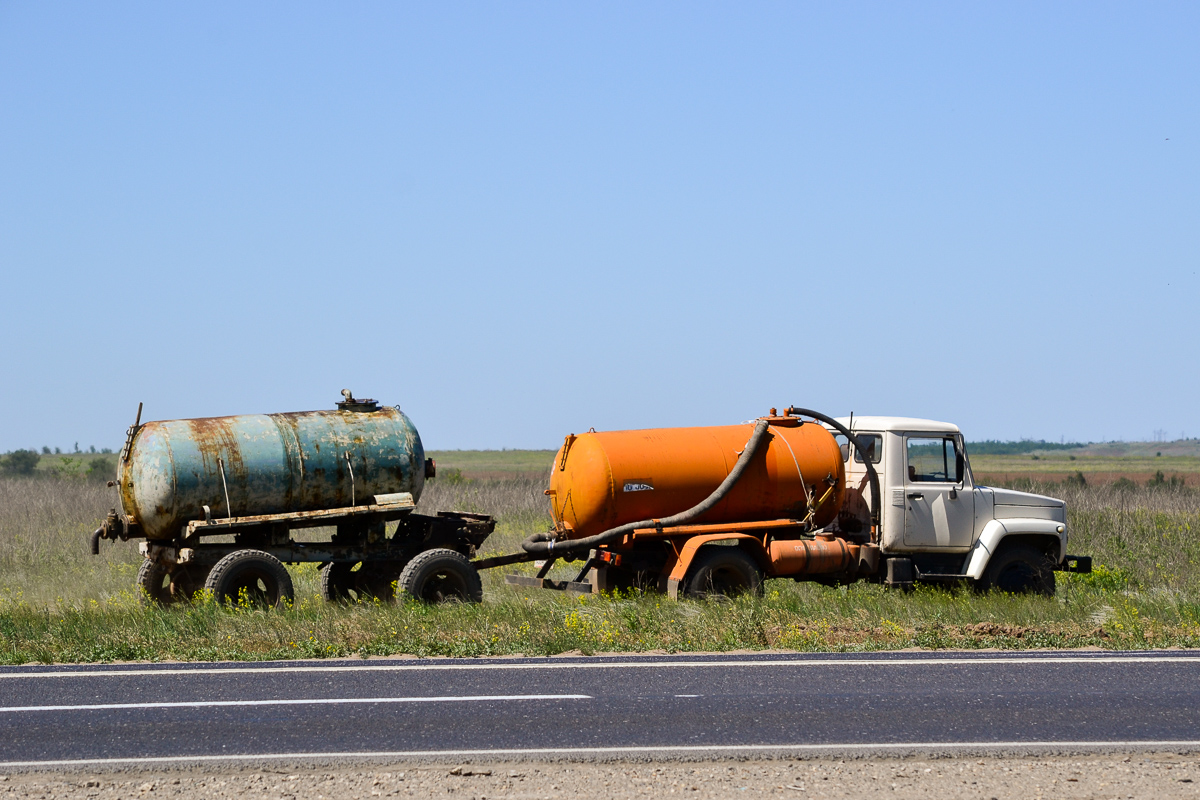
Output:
[{"xmin": 836, "ymin": 416, "xmax": 1091, "ymax": 594}]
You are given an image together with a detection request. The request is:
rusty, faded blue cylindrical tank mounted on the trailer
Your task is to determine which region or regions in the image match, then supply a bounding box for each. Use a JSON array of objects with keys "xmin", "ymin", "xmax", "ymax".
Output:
[{"xmin": 118, "ymin": 391, "xmax": 426, "ymax": 540}]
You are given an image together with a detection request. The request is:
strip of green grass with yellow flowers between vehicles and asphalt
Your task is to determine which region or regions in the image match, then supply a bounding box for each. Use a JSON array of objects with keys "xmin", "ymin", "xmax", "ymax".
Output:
[{"xmin": 0, "ymin": 581, "xmax": 1200, "ymax": 663}]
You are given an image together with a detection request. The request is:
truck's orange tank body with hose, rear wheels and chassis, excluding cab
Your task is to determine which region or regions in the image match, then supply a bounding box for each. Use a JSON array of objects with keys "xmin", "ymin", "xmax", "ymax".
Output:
[{"xmin": 506, "ymin": 409, "xmax": 880, "ymax": 597}]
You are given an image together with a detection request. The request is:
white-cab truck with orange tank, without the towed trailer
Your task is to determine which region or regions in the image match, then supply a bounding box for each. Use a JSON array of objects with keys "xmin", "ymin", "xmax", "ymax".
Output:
[{"xmin": 501, "ymin": 407, "xmax": 1091, "ymax": 597}]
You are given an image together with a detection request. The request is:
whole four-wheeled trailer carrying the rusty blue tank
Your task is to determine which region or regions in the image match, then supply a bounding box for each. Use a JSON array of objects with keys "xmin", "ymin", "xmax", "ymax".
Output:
[{"xmin": 91, "ymin": 390, "xmax": 496, "ymax": 607}]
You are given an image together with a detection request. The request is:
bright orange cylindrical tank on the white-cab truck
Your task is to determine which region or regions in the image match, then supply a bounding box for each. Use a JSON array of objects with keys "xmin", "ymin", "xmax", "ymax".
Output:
[{"xmin": 546, "ymin": 417, "xmax": 845, "ymax": 539}]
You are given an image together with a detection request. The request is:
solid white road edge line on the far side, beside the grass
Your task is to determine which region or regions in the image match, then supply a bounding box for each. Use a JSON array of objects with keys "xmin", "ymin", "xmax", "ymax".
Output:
[{"xmin": 0, "ymin": 655, "xmax": 1200, "ymax": 680}]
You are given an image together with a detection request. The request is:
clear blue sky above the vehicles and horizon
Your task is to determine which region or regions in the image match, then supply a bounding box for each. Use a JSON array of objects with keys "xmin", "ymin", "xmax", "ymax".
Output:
[{"xmin": 0, "ymin": 0, "xmax": 1200, "ymax": 450}]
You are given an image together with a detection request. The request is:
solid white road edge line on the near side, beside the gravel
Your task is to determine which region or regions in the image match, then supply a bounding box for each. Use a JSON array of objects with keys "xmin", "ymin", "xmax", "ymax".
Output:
[{"xmin": 0, "ymin": 739, "xmax": 1200, "ymax": 769}]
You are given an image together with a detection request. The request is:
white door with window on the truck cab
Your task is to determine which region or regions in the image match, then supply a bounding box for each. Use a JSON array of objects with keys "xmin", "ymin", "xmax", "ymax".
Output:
[{"xmin": 904, "ymin": 433, "xmax": 974, "ymax": 551}]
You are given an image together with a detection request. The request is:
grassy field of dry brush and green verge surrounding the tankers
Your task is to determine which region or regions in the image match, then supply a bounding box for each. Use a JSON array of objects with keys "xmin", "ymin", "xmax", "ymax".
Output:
[{"xmin": 0, "ymin": 451, "xmax": 1200, "ymax": 663}]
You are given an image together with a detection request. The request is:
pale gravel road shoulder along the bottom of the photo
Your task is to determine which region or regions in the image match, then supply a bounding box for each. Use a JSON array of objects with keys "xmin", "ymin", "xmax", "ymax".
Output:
[{"xmin": 0, "ymin": 753, "xmax": 1200, "ymax": 800}]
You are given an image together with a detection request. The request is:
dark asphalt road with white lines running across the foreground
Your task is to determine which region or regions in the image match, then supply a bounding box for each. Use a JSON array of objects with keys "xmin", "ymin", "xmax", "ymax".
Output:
[{"xmin": 0, "ymin": 651, "xmax": 1200, "ymax": 769}]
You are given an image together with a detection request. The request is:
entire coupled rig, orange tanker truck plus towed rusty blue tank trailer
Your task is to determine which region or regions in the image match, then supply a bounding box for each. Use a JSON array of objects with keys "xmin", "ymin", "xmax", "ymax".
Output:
[{"xmin": 91, "ymin": 400, "xmax": 1091, "ymax": 607}]
